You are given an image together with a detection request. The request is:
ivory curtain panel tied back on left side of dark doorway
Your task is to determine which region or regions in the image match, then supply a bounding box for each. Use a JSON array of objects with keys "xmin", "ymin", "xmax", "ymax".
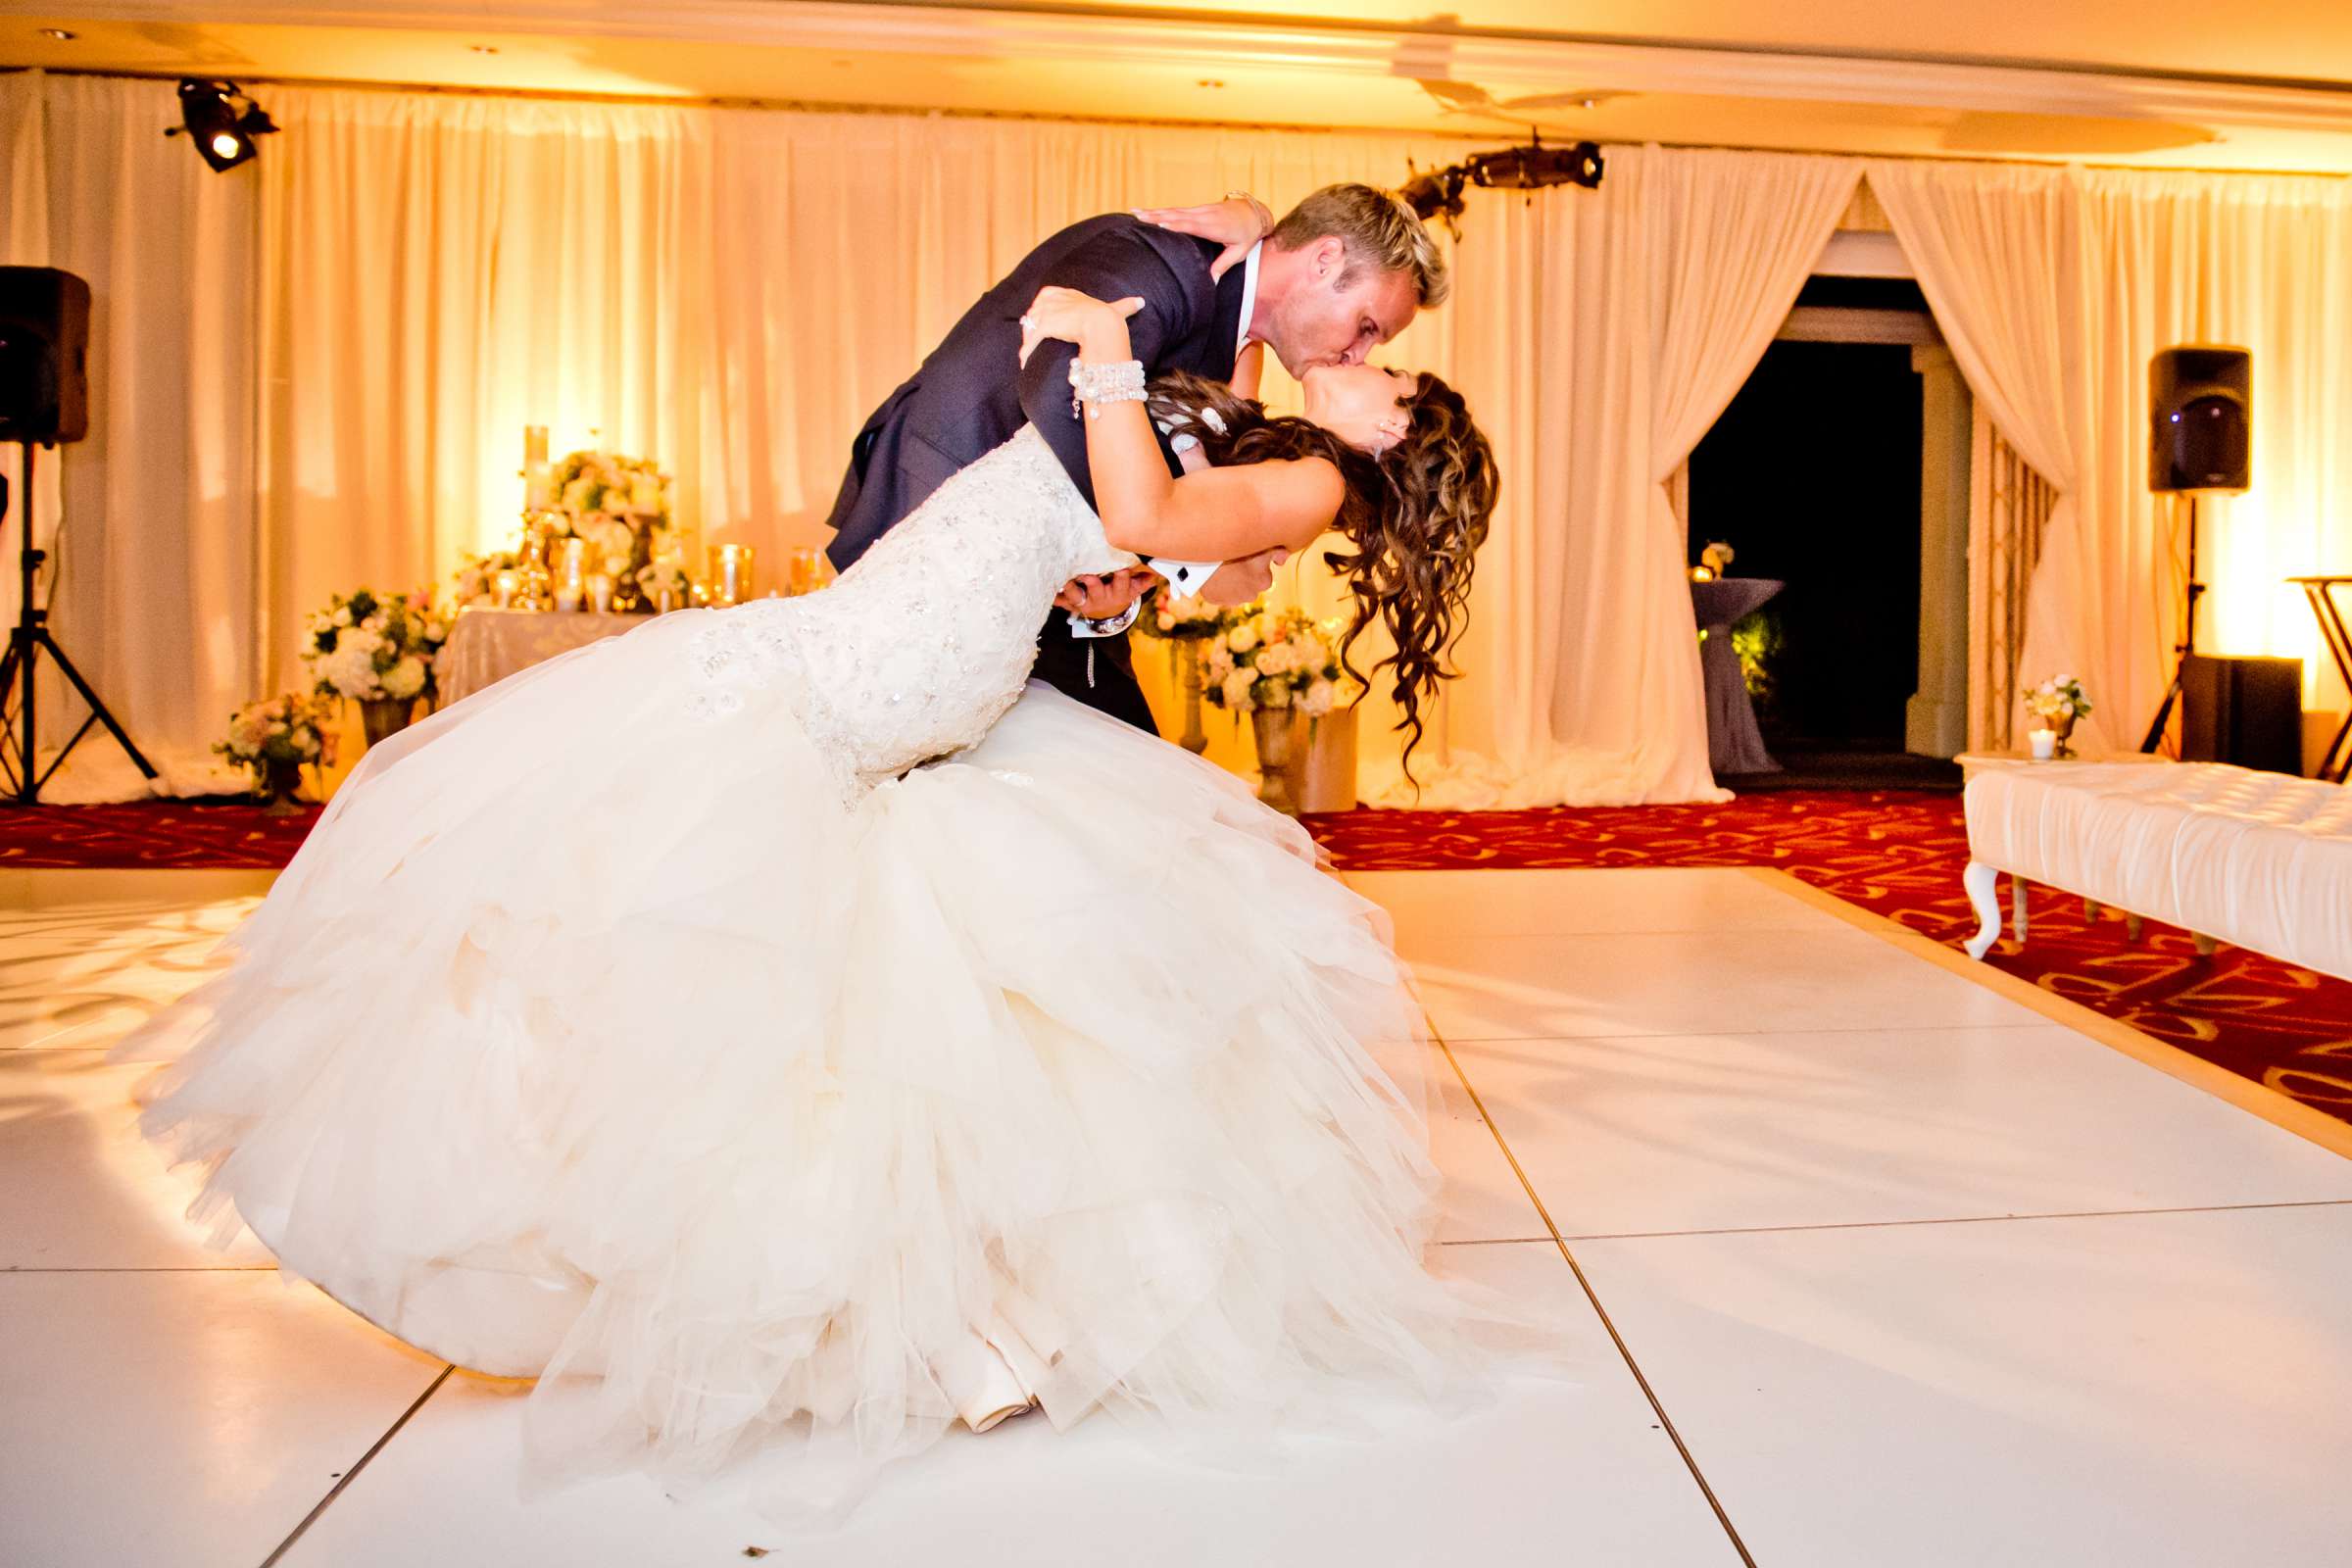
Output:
[{"xmin": 1326, "ymin": 146, "xmax": 1860, "ymax": 808}]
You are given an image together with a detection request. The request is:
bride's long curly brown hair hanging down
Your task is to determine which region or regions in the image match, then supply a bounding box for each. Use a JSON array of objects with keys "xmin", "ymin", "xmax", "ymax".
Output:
[{"xmin": 1151, "ymin": 371, "xmax": 1500, "ymax": 778}]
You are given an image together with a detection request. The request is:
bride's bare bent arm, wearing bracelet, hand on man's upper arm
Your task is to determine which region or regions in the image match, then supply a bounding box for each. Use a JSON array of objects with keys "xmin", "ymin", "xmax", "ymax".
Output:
[{"xmin": 1023, "ymin": 289, "xmax": 1346, "ymax": 562}]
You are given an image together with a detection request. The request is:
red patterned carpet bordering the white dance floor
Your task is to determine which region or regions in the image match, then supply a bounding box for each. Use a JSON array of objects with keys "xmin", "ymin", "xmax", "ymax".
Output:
[{"xmin": 0, "ymin": 790, "xmax": 2352, "ymax": 1121}]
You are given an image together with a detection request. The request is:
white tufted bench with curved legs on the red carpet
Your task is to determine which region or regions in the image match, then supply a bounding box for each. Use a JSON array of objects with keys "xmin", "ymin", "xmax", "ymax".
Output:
[{"xmin": 1964, "ymin": 761, "xmax": 2352, "ymax": 980}]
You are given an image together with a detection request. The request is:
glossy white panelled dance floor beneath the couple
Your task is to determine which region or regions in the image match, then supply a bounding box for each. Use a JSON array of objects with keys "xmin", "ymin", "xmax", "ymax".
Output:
[{"xmin": 0, "ymin": 870, "xmax": 2352, "ymax": 1568}]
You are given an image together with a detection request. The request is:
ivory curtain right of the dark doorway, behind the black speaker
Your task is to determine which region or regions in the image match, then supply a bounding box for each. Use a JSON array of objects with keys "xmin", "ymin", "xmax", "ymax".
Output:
[{"xmin": 1868, "ymin": 160, "xmax": 2352, "ymax": 755}]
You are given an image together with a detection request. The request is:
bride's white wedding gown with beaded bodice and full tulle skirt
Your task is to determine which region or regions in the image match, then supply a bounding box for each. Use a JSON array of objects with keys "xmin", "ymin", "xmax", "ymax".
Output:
[{"xmin": 118, "ymin": 430, "xmax": 1571, "ymax": 1504}]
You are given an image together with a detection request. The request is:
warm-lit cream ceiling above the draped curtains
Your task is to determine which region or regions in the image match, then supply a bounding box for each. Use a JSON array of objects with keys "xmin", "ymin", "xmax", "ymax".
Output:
[{"xmin": 14, "ymin": 0, "xmax": 2352, "ymax": 174}]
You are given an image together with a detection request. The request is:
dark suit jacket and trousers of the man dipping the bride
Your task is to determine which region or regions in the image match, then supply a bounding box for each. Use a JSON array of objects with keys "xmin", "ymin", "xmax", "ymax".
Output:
[{"xmin": 825, "ymin": 214, "xmax": 1242, "ymax": 729}]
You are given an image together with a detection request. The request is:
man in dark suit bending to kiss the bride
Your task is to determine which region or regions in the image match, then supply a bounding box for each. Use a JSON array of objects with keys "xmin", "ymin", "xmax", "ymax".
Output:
[{"xmin": 825, "ymin": 186, "xmax": 1448, "ymax": 733}]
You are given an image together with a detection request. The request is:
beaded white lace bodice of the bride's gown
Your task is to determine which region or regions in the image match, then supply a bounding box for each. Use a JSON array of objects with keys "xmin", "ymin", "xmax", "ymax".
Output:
[{"xmin": 689, "ymin": 425, "xmax": 1136, "ymax": 785}]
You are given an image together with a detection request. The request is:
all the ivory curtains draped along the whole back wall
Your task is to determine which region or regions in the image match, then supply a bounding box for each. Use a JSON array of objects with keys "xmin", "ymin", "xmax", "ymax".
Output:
[{"xmin": 14, "ymin": 73, "xmax": 2352, "ymax": 807}]
